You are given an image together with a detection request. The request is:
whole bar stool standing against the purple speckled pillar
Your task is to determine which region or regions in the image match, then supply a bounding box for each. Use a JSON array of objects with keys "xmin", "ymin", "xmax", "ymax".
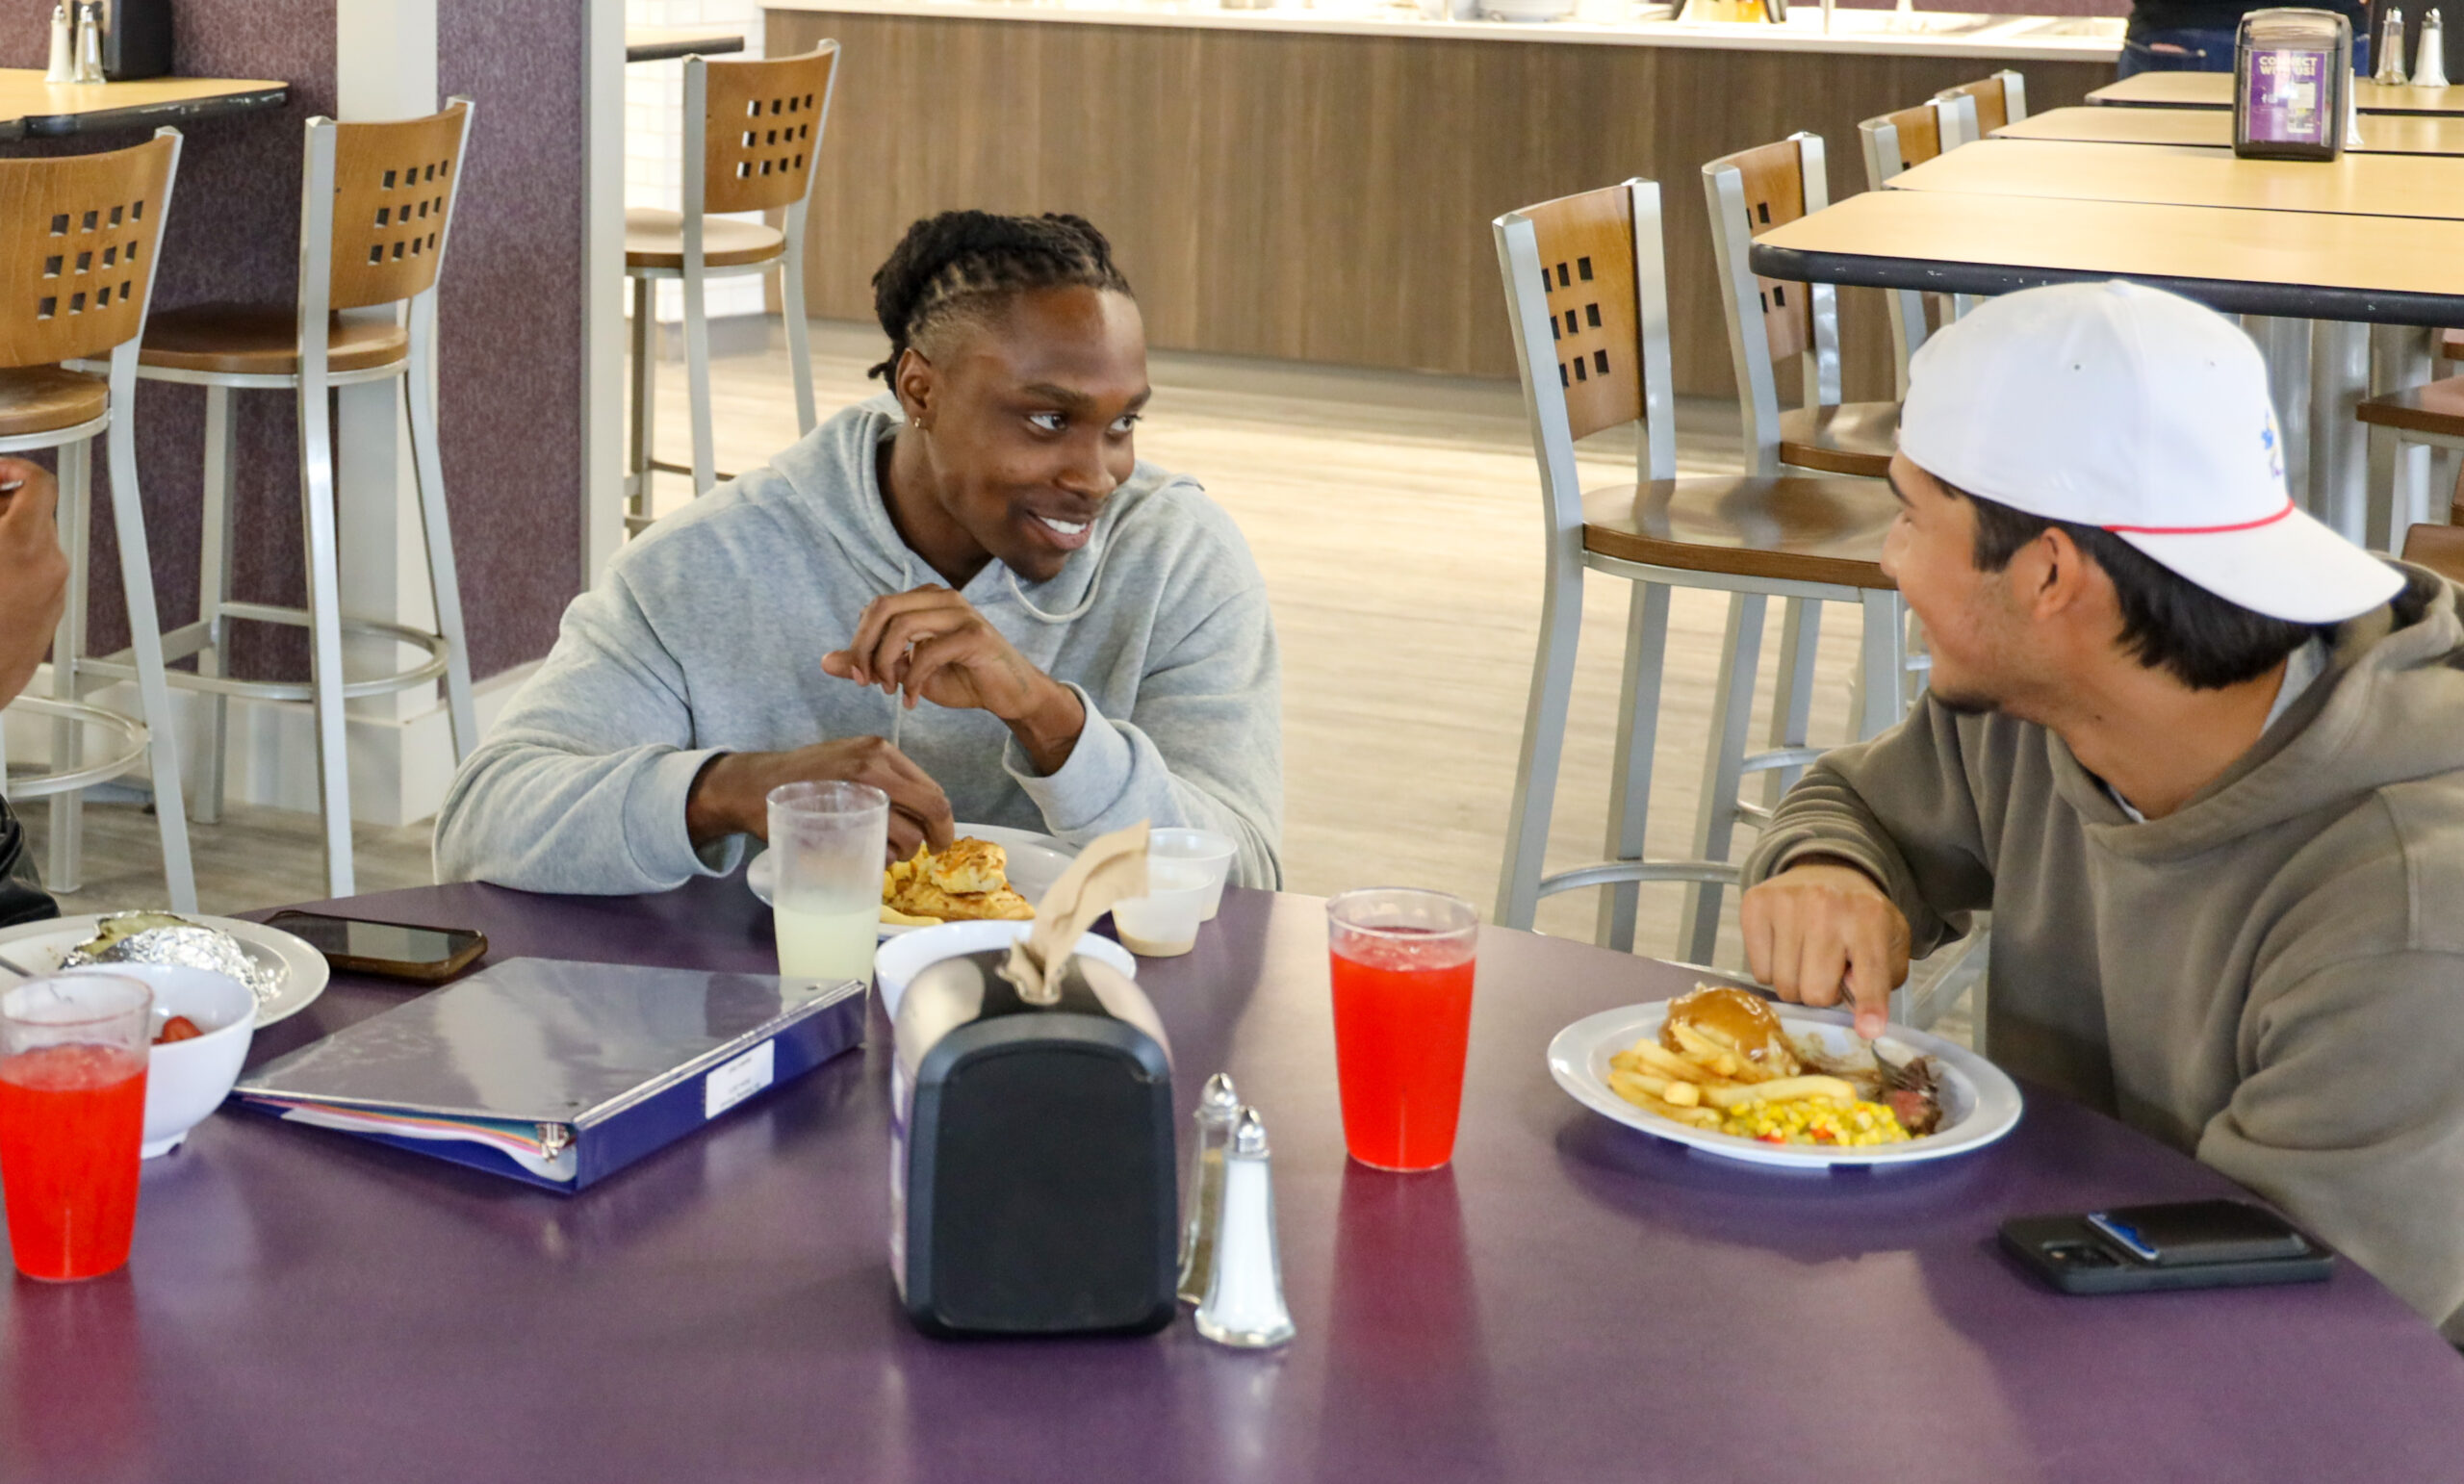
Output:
[{"xmin": 83, "ymin": 98, "xmax": 478, "ymax": 897}]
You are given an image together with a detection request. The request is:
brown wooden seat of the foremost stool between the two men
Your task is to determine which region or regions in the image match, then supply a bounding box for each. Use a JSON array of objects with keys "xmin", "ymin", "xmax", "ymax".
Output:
[{"xmin": 1582, "ymin": 475, "xmax": 1900, "ymax": 589}]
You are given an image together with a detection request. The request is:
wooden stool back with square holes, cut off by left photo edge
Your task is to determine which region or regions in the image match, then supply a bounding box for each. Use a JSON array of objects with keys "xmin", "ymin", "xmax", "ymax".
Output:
[{"xmin": 0, "ymin": 128, "xmax": 180, "ymax": 370}]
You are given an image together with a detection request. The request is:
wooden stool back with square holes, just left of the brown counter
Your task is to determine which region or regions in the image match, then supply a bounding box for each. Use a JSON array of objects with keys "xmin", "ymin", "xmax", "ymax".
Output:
[{"xmin": 685, "ymin": 42, "xmax": 837, "ymax": 212}]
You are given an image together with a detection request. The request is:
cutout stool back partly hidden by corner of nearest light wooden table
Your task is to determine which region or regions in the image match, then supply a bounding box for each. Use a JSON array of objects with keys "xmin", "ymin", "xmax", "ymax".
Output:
[{"xmin": 1703, "ymin": 133, "xmax": 1840, "ymax": 473}]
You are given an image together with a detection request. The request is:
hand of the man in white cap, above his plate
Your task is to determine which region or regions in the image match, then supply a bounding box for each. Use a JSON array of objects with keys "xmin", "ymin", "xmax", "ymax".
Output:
[{"xmin": 1739, "ymin": 860, "xmax": 1907, "ymax": 1040}]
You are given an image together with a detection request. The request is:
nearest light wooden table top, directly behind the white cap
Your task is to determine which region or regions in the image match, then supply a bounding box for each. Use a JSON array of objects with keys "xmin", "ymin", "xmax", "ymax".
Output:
[{"xmin": 1752, "ymin": 190, "xmax": 2464, "ymax": 325}]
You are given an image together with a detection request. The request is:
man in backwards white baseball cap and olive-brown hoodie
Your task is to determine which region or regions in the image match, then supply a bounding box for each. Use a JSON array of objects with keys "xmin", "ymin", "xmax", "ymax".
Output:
[{"xmin": 1744, "ymin": 284, "xmax": 2464, "ymax": 1339}]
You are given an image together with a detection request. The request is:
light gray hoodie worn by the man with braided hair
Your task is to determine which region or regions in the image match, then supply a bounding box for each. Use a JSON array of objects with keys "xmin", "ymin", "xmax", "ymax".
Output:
[{"xmin": 436, "ymin": 397, "xmax": 1284, "ymax": 892}]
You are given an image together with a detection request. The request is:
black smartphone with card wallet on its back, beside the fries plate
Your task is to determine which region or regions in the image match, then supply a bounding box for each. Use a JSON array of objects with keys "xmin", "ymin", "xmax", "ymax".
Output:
[{"xmin": 2001, "ymin": 1200, "xmax": 2336, "ymax": 1294}]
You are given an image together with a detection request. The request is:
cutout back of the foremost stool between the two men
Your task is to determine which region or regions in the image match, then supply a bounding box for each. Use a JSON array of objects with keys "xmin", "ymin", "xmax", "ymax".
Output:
[{"xmin": 1493, "ymin": 180, "xmax": 1676, "ymax": 530}]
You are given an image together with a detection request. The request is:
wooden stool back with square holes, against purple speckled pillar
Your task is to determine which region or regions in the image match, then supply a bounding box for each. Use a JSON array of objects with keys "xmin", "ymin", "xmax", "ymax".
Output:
[{"xmin": 308, "ymin": 98, "xmax": 471, "ymax": 308}]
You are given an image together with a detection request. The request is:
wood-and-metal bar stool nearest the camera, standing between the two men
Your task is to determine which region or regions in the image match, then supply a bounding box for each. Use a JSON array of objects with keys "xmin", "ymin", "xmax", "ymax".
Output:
[{"xmin": 1493, "ymin": 180, "xmax": 1902, "ymax": 964}]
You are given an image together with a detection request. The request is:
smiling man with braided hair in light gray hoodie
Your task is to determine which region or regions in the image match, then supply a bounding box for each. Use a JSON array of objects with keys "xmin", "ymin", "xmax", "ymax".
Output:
[{"xmin": 436, "ymin": 212, "xmax": 1284, "ymax": 892}]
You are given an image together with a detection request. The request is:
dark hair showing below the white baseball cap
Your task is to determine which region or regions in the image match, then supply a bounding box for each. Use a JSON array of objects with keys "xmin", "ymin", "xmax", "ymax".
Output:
[{"xmin": 1941, "ymin": 483, "xmax": 2336, "ymax": 690}]
